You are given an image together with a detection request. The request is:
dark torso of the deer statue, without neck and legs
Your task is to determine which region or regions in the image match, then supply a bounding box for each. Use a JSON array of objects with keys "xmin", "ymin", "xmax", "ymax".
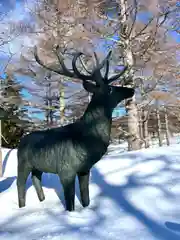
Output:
[{"xmin": 18, "ymin": 122, "xmax": 107, "ymax": 173}]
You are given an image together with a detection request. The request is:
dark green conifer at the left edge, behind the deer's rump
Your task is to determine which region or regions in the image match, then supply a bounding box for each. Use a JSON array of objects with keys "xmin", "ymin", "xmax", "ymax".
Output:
[{"xmin": 0, "ymin": 75, "xmax": 24, "ymax": 148}]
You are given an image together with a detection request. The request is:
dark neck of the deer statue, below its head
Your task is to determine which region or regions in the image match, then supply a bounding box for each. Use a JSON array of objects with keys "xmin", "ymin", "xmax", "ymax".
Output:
[{"xmin": 81, "ymin": 96, "xmax": 113, "ymax": 144}]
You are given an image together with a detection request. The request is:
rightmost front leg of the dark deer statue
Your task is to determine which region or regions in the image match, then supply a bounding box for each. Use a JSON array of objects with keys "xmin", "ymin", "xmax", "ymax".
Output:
[{"xmin": 78, "ymin": 171, "xmax": 90, "ymax": 207}]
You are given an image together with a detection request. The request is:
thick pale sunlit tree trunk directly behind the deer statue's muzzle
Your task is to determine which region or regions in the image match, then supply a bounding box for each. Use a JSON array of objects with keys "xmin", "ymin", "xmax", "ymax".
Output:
[{"xmin": 119, "ymin": 0, "xmax": 141, "ymax": 150}]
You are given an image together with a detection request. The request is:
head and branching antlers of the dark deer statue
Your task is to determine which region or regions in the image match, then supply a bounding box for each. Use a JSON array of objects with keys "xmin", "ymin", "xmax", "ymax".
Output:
[{"xmin": 34, "ymin": 47, "xmax": 134, "ymax": 108}]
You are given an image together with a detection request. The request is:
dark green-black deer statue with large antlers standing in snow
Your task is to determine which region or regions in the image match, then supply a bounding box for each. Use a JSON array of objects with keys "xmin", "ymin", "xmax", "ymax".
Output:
[{"xmin": 17, "ymin": 47, "xmax": 134, "ymax": 211}]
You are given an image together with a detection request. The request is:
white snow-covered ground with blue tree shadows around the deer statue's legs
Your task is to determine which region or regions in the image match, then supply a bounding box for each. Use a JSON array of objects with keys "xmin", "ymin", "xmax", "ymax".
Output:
[{"xmin": 0, "ymin": 144, "xmax": 180, "ymax": 240}]
